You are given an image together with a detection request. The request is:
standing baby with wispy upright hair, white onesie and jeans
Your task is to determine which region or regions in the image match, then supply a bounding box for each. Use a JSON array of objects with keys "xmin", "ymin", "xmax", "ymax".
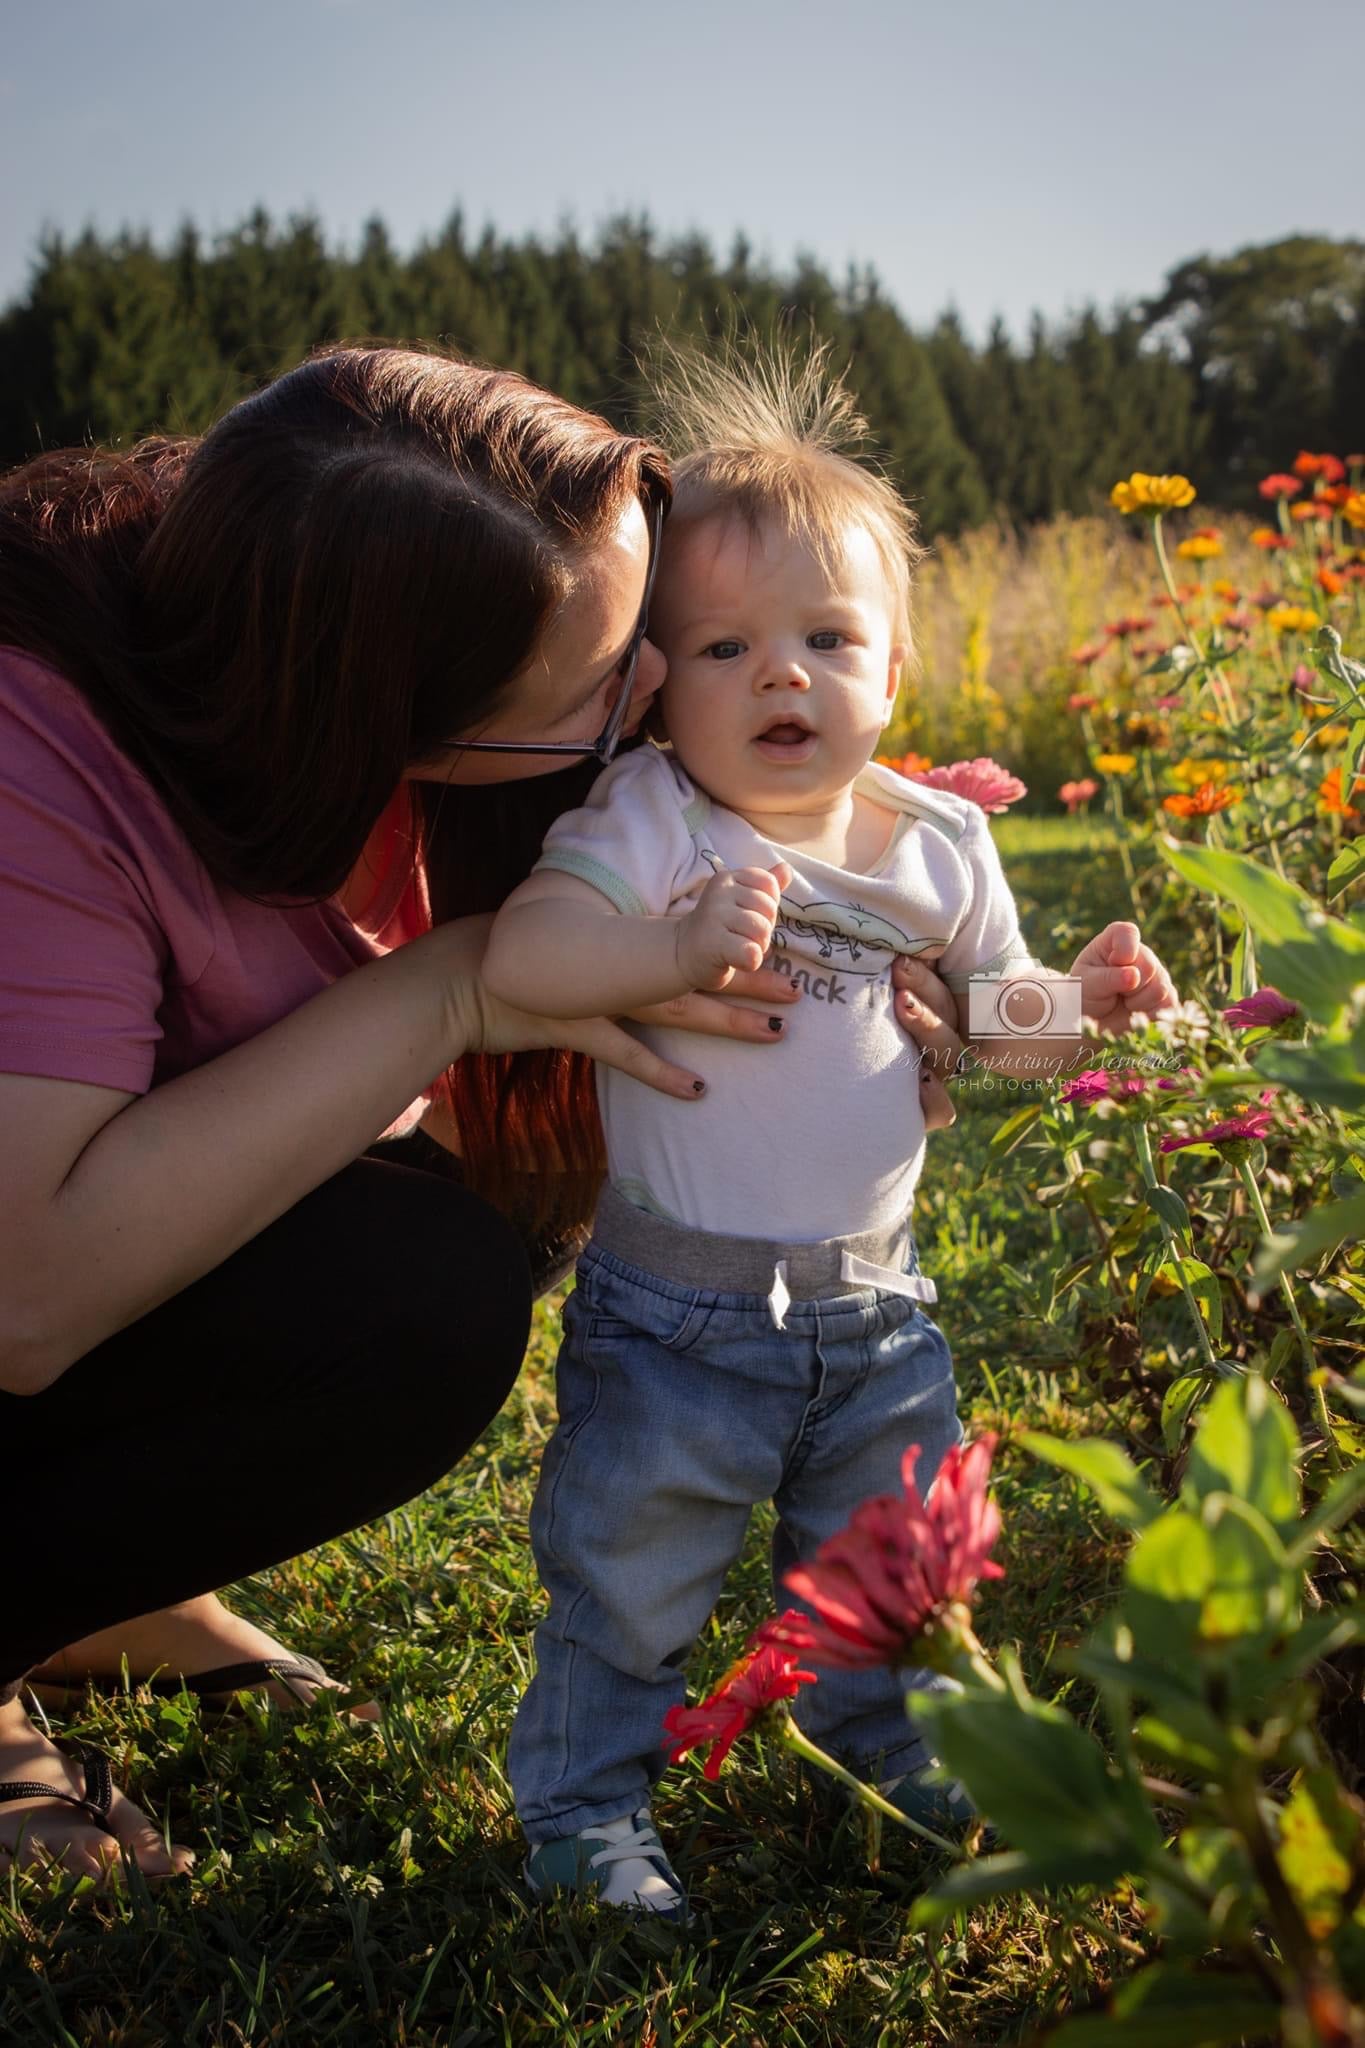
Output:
[{"xmin": 485, "ymin": 365, "xmax": 1173, "ymax": 1917}]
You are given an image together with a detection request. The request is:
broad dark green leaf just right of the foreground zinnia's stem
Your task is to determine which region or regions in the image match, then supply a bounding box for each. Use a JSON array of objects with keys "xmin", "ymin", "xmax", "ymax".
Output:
[{"xmin": 915, "ymin": 1690, "xmax": 1160, "ymax": 1884}]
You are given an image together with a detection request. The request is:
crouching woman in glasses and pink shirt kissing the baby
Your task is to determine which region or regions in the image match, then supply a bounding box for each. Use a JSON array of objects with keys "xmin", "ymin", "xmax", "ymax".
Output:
[{"xmin": 0, "ymin": 348, "xmax": 956, "ymax": 1876}]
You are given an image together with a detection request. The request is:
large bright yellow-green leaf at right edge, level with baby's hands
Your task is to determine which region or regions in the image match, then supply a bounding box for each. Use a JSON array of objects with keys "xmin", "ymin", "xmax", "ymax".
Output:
[{"xmin": 1158, "ymin": 836, "xmax": 1365, "ymax": 1024}]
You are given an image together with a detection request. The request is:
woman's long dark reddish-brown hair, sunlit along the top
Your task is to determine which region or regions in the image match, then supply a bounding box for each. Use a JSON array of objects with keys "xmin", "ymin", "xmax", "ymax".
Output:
[{"xmin": 0, "ymin": 348, "xmax": 669, "ymax": 1221}]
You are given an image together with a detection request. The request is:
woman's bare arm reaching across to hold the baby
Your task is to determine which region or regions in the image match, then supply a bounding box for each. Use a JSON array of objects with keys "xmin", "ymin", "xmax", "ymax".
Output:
[{"xmin": 0, "ymin": 918, "xmax": 696, "ymax": 1395}]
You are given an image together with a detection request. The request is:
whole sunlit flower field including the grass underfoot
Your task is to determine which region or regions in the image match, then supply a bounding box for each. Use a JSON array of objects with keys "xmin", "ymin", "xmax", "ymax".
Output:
[{"xmin": 0, "ymin": 453, "xmax": 1365, "ymax": 2048}]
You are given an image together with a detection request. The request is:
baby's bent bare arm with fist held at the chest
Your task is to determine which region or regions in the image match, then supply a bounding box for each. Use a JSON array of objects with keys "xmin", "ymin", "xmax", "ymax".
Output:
[{"xmin": 483, "ymin": 860, "xmax": 792, "ymax": 1018}]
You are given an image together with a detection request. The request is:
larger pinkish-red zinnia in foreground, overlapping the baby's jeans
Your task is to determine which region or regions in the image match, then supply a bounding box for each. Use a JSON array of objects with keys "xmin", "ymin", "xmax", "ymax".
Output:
[{"xmin": 769, "ymin": 1436, "xmax": 1003, "ymax": 1671}]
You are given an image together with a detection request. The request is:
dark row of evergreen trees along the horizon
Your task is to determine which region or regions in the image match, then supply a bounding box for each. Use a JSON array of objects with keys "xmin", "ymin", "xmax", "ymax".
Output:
[{"xmin": 0, "ymin": 211, "xmax": 1365, "ymax": 535}]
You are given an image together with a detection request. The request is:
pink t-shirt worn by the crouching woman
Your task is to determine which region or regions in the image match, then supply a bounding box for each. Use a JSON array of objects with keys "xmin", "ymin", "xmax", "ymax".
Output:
[{"xmin": 0, "ymin": 647, "xmax": 430, "ymax": 1130}]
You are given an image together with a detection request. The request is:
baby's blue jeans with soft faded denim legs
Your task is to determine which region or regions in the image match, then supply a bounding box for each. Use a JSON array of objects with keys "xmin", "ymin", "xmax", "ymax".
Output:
[{"xmin": 508, "ymin": 1245, "xmax": 962, "ymax": 1845}]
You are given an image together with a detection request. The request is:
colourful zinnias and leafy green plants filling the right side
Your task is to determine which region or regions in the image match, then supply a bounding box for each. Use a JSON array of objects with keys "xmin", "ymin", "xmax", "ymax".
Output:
[{"xmin": 669, "ymin": 451, "xmax": 1365, "ymax": 2048}]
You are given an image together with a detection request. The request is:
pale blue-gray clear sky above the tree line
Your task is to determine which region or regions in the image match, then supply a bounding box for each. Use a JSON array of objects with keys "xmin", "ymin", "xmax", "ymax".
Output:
[{"xmin": 0, "ymin": 0, "xmax": 1365, "ymax": 336}]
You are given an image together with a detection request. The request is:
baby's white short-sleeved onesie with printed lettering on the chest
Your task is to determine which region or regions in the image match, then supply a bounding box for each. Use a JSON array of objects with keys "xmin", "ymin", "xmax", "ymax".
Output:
[{"xmin": 536, "ymin": 745, "xmax": 1038, "ymax": 1243}]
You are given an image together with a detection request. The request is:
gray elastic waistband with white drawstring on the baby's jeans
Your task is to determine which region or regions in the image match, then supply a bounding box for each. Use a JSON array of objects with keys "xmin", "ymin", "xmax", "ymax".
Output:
[{"xmin": 593, "ymin": 1186, "xmax": 933, "ymax": 1300}]
